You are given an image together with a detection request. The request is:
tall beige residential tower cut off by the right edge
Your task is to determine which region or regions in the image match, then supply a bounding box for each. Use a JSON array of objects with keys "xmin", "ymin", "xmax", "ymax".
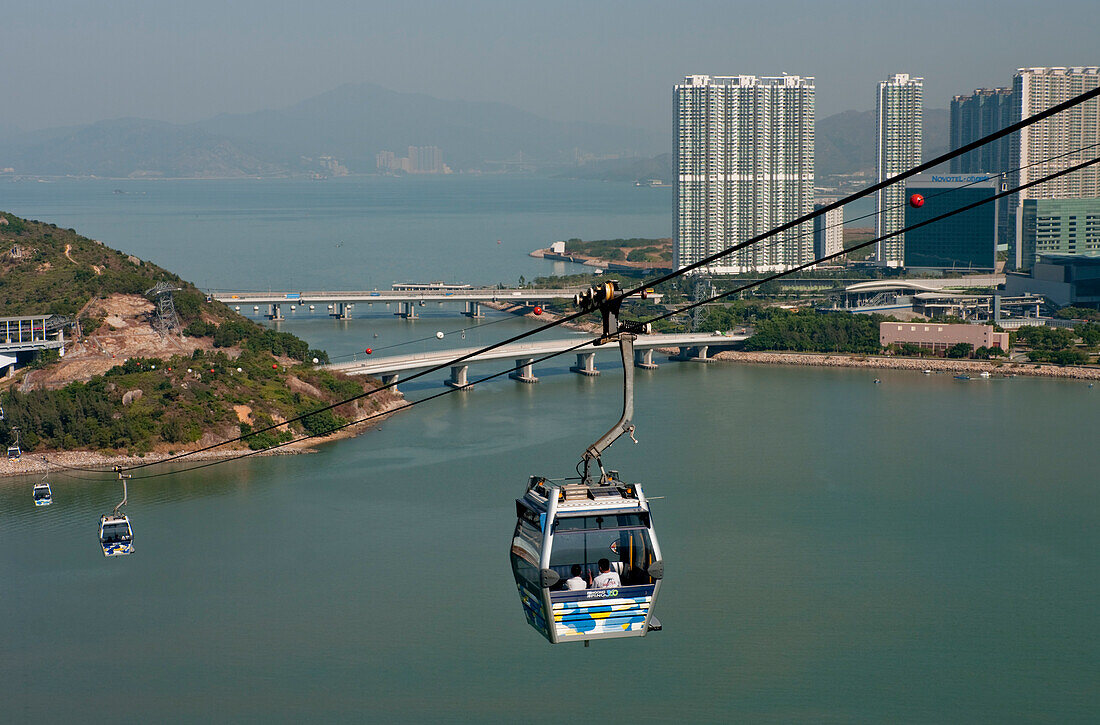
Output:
[{"xmin": 1011, "ymin": 66, "xmax": 1100, "ymax": 270}]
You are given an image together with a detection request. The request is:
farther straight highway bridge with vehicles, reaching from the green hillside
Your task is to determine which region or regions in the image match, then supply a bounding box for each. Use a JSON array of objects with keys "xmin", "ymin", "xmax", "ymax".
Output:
[{"xmin": 210, "ymin": 285, "xmax": 661, "ymax": 320}]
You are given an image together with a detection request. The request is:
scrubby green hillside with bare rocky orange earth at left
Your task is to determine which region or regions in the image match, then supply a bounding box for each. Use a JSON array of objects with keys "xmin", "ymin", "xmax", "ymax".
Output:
[{"xmin": 0, "ymin": 212, "xmax": 402, "ymax": 473}]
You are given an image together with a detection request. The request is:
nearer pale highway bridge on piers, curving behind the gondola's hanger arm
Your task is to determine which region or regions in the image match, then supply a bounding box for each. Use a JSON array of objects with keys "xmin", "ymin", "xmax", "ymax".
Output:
[{"xmin": 325, "ymin": 329, "xmax": 752, "ymax": 388}]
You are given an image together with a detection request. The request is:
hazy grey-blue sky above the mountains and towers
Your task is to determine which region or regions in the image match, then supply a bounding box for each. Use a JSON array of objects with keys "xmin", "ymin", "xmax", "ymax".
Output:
[{"xmin": 0, "ymin": 0, "xmax": 1100, "ymax": 130}]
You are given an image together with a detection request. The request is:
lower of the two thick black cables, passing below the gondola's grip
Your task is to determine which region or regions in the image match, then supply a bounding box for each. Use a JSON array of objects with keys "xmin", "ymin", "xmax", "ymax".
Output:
[{"xmin": 70, "ymin": 156, "xmax": 1100, "ymax": 480}]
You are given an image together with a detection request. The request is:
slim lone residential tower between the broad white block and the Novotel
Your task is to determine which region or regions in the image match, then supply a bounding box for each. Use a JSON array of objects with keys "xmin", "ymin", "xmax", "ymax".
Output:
[{"xmin": 875, "ymin": 73, "xmax": 924, "ymax": 267}]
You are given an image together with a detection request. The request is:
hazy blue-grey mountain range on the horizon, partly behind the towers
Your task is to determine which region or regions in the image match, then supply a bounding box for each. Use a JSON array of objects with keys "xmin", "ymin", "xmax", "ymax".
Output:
[{"xmin": 0, "ymin": 84, "xmax": 947, "ymax": 180}]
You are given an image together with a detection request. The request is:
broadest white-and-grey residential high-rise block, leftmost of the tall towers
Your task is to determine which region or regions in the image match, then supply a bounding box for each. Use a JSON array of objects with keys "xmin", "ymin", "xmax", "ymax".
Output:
[{"xmin": 673, "ymin": 75, "xmax": 814, "ymax": 274}]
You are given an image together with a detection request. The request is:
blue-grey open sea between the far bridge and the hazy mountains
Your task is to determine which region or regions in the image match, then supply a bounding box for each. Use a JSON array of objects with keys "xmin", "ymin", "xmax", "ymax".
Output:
[{"xmin": 0, "ymin": 176, "xmax": 672, "ymax": 290}]
